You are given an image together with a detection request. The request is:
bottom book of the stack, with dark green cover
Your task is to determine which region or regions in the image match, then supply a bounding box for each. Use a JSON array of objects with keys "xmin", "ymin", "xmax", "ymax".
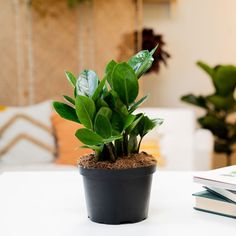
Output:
[{"xmin": 193, "ymin": 191, "xmax": 236, "ymax": 218}]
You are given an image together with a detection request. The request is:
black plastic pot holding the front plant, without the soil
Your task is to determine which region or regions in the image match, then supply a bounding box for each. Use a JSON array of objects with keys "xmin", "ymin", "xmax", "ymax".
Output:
[{"xmin": 79, "ymin": 166, "xmax": 156, "ymax": 224}]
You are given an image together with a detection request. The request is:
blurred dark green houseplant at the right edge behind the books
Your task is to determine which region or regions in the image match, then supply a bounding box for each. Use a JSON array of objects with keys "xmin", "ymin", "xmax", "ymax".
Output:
[{"xmin": 181, "ymin": 61, "xmax": 236, "ymax": 165}]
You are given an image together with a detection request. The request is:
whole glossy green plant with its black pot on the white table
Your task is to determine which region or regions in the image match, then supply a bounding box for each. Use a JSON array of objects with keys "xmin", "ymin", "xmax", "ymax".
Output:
[{"xmin": 53, "ymin": 48, "xmax": 163, "ymax": 224}]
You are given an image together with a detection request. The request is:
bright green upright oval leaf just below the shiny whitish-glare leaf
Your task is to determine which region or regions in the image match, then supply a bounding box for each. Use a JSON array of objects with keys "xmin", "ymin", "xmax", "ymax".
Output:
[{"xmin": 75, "ymin": 96, "xmax": 96, "ymax": 129}]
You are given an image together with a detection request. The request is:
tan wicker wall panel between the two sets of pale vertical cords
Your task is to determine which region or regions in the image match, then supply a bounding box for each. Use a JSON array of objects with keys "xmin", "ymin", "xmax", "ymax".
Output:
[{"xmin": 31, "ymin": 0, "xmax": 78, "ymax": 102}]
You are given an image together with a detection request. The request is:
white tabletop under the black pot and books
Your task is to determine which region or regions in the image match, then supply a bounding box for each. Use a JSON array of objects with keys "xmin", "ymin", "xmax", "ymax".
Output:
[{"xmin": 0, "ymin": 171, "xmax": 236, "ymax": 236}]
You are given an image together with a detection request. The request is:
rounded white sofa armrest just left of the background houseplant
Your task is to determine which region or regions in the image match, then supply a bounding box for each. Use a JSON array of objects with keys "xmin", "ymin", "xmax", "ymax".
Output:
[{"xmin": 193, "ymin": 129, "xmax": 214, "ymax": 170}]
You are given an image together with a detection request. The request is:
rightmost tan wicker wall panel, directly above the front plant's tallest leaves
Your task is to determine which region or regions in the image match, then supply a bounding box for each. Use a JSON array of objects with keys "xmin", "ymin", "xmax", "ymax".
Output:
[{"xmin": 94, "ymin": 0, "xmax": 137, "ymax": 74}]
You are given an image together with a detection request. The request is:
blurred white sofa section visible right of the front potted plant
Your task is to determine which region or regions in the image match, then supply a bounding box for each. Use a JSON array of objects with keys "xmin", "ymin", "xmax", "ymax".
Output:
[{"xmin": 137, "ymin": 107, "xmax": 214, "ymax": 170}]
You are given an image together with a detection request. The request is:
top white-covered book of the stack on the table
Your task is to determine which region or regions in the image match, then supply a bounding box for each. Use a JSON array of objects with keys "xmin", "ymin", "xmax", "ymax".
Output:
[{"xmin": 193, "ymin": 165, "xmax": 236, "ymax": 191}]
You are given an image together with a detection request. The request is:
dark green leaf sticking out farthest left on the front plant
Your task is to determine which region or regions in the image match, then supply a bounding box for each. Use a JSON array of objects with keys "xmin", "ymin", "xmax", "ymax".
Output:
[{"xmin": 53, "ymin": 102, "xmax": 80, "ymax": 123}]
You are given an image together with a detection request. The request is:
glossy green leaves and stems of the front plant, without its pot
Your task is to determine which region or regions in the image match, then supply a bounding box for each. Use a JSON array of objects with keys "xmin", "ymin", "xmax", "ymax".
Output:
[{"xmin": 53, "ymin": 48, "xmax": 163, "ymax": 162}]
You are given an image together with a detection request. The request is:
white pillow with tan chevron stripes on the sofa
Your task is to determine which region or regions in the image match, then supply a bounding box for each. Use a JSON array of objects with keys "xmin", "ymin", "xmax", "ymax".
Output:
[{"xmin": 0, "ymin": 101, "xmax": 55, "ymax": 166}]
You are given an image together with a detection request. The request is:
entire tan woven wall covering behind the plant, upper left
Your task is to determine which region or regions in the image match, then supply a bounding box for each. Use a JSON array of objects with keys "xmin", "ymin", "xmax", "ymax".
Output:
[{"xmin": 0, "ymin": 0, "xmax": 139, "ymax": 105}]
